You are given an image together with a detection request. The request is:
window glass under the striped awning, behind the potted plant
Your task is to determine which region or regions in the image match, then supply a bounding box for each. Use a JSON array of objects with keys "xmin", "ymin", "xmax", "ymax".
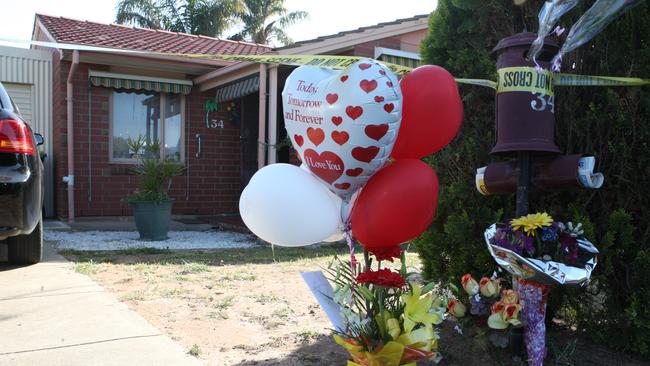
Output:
[{"xmin": 110, "ymin": 91, "xmax": 185, "ymax": 162}]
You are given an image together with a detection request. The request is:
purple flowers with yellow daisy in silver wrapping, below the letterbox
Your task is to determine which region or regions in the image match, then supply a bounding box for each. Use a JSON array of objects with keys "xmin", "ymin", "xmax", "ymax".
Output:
[{"xmin": 485, "ymin": 212, "xmax": 598, "ymax": 366}]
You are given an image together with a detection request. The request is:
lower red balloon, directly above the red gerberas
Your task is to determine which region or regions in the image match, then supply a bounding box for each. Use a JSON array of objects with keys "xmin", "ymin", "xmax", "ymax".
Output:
[{"xmin": 350, "ymin": 159, "xmax": 438, "ymax": 248}]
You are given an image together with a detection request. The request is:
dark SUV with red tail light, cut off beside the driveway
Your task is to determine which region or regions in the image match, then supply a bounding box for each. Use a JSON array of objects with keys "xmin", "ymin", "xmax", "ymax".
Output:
[{"xmin": 0, "ymin": 83, "xmax": 44, "ymax": 264}]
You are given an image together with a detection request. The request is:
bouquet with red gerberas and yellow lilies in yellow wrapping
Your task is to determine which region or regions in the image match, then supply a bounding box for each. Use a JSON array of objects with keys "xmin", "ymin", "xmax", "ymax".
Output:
[{"xmin": 327, "ymin": 247, "xmax": 446, "ymax": 366}]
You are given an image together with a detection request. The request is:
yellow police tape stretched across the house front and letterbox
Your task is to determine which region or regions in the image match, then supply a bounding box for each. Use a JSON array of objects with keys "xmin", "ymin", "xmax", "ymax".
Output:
[{"xmin": 0, "ymin": 38, "xmax": 650, "ymax": 90}]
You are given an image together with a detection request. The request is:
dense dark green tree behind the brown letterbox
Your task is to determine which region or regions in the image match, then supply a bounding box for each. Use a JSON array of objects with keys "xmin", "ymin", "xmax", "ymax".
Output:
[{"xmin": 416, "ymin": 0, "xmax": 650, "ymax": 355}]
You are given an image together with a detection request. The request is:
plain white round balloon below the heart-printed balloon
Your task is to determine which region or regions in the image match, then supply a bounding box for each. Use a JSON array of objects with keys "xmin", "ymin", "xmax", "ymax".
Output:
[{"xmin": 239, "ymin": 164, "xmax": 341, "ymax": 247}]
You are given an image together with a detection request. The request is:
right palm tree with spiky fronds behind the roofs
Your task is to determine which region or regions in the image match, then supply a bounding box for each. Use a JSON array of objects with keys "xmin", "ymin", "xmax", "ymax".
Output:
[{"xmin": 231, "ymin": 0, "xmax": 308, "ymax": 44}]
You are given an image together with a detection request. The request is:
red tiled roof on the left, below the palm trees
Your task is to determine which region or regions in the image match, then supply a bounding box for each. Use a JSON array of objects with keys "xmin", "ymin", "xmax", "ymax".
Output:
[{"xmin": 36, "ymin": 14, "xmax": 271, "ymax": 55}]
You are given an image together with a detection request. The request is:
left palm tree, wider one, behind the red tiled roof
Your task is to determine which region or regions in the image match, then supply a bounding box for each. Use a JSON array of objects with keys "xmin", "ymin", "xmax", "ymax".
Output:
[{"xmin": 115, "ymin": 0, "xmax": 243, "ymax": 37}]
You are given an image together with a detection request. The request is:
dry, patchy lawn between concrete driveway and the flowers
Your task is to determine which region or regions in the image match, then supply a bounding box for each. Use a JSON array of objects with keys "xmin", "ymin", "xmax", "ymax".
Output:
[{"xmin": 61, "ymin": 242, "xmax": 419, "ymax": 365}]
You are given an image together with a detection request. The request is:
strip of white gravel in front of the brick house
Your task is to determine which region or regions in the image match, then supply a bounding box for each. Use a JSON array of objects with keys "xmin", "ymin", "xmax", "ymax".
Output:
[{"xmin": 44, "ymin": 230, "xmax": 257, "ymax": 250}]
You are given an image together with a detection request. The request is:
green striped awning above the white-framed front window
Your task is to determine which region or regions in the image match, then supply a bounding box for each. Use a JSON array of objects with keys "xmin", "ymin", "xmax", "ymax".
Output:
[{"xmin": 89, "ymin": 71, "xmax": 192, "ymax": 94}]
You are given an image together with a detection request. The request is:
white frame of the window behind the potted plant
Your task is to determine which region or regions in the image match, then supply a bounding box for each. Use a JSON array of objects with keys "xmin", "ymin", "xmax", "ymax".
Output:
[{"xmin": 108, "ymin": 89, "xmax": 186, "ymax": 165}]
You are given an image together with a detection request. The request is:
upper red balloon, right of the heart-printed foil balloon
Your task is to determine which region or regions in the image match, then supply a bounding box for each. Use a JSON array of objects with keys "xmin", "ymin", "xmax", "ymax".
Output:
[{"xmin": 391, "ymin": 65, "xmax": 463, "ymax": 159}]
